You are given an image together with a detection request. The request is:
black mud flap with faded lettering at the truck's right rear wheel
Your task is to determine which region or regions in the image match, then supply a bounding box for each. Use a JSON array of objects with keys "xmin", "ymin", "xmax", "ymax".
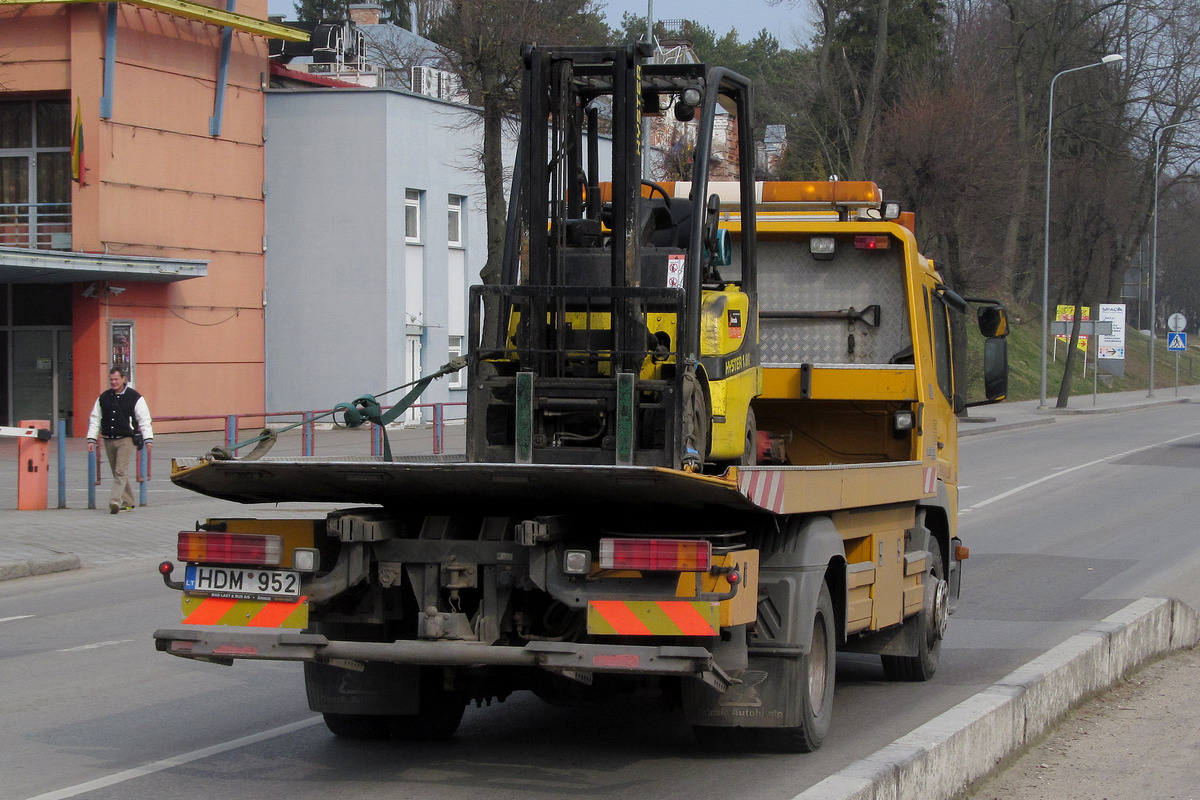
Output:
[{"xmin": 683, "ymin": 656, "xmax": 806, "ymax": 728}]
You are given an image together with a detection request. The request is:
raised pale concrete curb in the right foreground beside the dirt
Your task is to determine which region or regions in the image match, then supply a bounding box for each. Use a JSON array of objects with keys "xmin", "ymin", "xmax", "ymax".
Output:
[{"xmin": 793, "ymin": 597, "xmax": 1200, "ymax": 800}]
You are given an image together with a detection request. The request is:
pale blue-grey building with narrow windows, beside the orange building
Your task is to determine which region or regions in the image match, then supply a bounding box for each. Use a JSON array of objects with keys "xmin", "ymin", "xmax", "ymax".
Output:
[{"xmin": 265, "ymin": 89, "xmax": 487, "ymax": 420}]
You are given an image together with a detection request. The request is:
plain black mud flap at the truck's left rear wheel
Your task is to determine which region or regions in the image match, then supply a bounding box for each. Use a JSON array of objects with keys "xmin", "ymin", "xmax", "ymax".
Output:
[{"xmin": 304, "ymin": 661, "xmax": 421, "ymax": 715}]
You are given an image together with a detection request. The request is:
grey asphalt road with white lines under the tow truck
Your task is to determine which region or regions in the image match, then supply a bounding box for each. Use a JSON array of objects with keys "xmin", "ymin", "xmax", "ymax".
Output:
[{"xmin": 7, "ymin": 404, "xmax": 1200, "ymax": 800}]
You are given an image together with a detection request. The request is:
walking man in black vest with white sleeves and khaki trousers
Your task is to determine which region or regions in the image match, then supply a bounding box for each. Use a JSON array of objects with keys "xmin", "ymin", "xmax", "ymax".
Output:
[{"xmin": 88, "ymin": 367, "xmax": 154, "ymax": 513}]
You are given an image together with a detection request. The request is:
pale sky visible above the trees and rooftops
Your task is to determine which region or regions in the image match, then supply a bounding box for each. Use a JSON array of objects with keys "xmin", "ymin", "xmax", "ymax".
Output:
[{"xmin": 268, "ymin": 0, "xmax": 810, "ymax": 49}]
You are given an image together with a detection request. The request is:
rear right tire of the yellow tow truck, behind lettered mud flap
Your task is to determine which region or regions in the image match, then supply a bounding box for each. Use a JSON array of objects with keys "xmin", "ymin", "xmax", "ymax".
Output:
[{"xmin": 762, "ymin": 582, "xmax": 838, "ymax": 753}]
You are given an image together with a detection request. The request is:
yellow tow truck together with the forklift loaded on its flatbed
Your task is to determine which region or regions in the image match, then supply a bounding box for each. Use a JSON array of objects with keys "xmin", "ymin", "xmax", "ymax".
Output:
[{"xmin": 155, "ymin": 46, "xmax": 1007, "ymax": 752}]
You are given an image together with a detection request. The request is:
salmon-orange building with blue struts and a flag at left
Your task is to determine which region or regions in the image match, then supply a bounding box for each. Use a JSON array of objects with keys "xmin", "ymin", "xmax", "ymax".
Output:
[{"xmin": 0, "ymin": 0, "xmax": 300, "ymax": 435}]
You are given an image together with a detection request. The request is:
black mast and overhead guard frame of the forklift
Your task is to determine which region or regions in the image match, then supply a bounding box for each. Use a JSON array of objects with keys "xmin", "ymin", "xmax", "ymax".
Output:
[{"xmin": 467, "ymin": 43, "xmax": 757, "ymax": 468}]
